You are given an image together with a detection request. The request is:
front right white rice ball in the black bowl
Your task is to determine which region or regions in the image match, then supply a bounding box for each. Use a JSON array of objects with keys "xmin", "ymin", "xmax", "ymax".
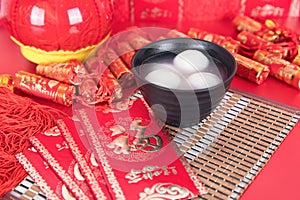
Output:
[{"xmin": 187, "ymin": 72, "xmax": 222, "ymax": 89}]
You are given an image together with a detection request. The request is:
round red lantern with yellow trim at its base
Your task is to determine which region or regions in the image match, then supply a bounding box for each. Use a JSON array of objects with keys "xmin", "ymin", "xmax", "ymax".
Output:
[{"xmin": 1, "ymin": 0, "xmax": 113, "ymax": 63}]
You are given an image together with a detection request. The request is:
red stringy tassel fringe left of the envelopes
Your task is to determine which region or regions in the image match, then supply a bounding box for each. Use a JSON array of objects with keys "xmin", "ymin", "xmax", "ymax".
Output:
[{"xmin": 0, "ymin": 87, "xmax": 67, "ymax": 197}]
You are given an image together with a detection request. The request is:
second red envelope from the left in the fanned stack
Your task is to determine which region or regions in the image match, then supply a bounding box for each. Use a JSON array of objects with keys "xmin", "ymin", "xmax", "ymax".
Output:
[{"xmin": 30, "ymin": 126, "xmax": 95, "ymax": 199}]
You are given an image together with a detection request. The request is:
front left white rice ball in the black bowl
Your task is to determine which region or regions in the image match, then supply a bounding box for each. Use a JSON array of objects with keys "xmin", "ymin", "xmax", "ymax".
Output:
[{"xmin": 145, "ymin": 69, "xmax": 181, "ymax": 89}]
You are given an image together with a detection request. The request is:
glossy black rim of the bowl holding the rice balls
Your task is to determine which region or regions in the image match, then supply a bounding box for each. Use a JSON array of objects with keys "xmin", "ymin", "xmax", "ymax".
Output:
[{"xmin": 131, "ymin": 38, "xmax": 237, "ymax": 93}]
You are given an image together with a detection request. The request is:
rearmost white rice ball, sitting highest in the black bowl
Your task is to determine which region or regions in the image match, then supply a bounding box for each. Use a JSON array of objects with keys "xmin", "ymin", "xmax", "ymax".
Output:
[{"xmin": 173, "ymin": 50, "xmax": 209, "ymax": 74}]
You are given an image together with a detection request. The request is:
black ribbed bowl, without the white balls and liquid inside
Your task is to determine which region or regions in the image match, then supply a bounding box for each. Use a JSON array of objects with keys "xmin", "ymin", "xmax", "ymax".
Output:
[{"xmin": 132, "ymin": 38, "xmax": 237, "ymax": 127}]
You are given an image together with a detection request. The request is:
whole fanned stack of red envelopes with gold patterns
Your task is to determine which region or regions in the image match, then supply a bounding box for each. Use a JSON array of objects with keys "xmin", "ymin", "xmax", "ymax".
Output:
[{"xmin": 17, "ymin": 99, "xmax": 206, "ymax": 200}]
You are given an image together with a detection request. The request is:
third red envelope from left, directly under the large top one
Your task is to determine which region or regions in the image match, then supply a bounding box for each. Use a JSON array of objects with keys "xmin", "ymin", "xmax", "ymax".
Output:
[{"xmin": 57, "ymin": 118, "xmax": 111, "ymax": 199}]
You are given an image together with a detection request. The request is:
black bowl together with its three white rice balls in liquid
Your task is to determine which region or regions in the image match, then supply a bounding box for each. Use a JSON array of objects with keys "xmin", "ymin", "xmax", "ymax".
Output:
[{"xmin": 132, "ymin": 38, "xmax": 236, "ymax": 127}]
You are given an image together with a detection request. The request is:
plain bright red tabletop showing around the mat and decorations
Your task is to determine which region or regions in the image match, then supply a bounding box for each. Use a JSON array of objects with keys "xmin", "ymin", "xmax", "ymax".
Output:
[{"xmin": 0, "ymin": 18, "xmax": 300, "ymax": 200}]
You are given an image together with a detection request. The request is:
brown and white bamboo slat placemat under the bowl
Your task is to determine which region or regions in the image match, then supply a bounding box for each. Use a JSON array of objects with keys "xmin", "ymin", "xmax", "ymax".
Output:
[{"xmin": 11, "ymin": 90, "xmax": 300, "ymax": 199}]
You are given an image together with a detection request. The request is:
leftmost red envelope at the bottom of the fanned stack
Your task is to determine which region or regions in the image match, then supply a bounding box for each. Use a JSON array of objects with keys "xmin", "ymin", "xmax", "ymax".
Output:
[{"xmin": 16, "ymin": 147, "xmax": 74, "ymax": 200}]
